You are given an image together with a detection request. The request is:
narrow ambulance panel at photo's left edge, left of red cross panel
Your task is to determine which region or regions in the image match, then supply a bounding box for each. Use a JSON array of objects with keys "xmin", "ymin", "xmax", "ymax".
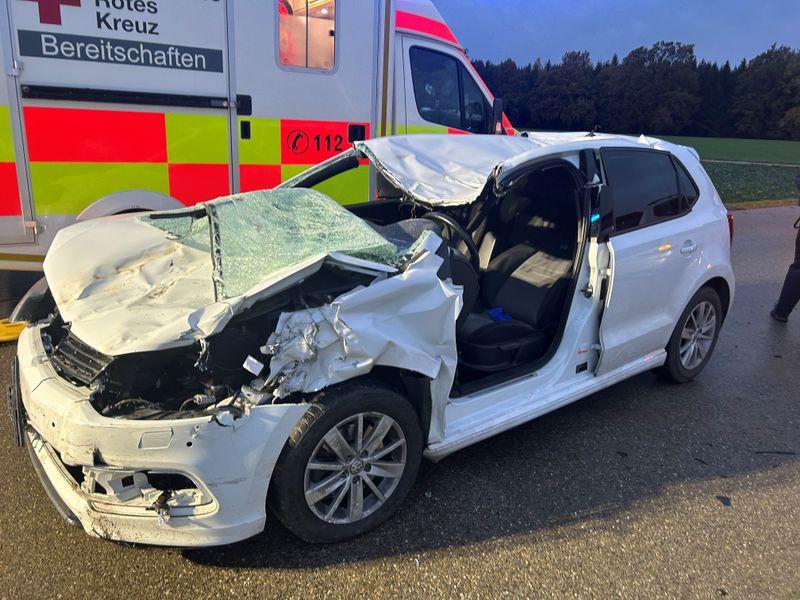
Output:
[{"xmin": 0, "ymin": 7, "xmax": 34, "ymax": 244}]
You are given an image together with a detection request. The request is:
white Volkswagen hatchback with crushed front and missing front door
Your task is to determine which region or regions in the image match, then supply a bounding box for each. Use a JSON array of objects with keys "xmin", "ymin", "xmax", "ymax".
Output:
[{"xmin": 8, "ymin": 133, "xmax": 734, "ymax": 546}]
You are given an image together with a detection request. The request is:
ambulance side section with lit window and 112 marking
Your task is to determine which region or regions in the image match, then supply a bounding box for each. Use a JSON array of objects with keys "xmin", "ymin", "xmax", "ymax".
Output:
[{"xmin": 233, "ymin": 0, "xmax": 382, "ymax": 204}]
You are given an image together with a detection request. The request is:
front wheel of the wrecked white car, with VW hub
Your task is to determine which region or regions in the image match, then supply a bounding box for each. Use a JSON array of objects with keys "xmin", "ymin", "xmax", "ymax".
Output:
[{"xmin": 268, "ymin": 379, "xmax": 423, "ymax": 543}]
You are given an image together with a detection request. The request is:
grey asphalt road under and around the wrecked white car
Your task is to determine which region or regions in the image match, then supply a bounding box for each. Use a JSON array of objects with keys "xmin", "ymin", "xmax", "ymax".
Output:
[{"xmin": 0, "ymin": 207, "xmax": 800, "ymax": 598}]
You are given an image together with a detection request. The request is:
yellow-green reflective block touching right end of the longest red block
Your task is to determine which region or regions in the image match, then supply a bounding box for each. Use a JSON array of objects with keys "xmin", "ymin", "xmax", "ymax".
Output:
[{"xmin": 165, "ymin": 113, "xmax": 228, "ymax": 165}]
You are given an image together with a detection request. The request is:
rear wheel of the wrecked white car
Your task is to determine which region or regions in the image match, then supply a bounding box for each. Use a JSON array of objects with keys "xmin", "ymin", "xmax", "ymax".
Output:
[{"xmin": 657, "ymin": 287, "xmax": 722, "ymax": 383}]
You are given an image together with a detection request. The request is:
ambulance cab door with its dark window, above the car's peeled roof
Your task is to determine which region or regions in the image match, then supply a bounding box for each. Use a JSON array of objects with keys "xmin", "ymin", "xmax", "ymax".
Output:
[{"xmin": 399, "ymin": 35, "xmax": 492, "ymax": 133}]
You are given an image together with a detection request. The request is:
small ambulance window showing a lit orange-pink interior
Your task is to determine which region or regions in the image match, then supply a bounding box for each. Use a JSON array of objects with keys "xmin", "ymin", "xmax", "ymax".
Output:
[{"xmin": 277, "ymin": 0, "xmax": 336, "ymax": 71}]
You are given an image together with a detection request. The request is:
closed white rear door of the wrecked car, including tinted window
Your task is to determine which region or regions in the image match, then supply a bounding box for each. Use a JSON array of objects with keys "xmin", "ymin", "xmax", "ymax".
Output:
[{"xmin": 596, "ymin": 148, "xmax": 702, "ymax": 375}]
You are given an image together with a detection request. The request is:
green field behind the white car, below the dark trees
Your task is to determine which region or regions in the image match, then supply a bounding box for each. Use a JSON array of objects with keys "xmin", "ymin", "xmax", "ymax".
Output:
[{"xmin": 663, "ymin": 136, "xmax": 800, "ymax": 203}]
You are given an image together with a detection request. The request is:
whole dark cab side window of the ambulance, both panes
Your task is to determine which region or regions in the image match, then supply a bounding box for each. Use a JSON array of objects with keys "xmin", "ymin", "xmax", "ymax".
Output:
[{"xmin": 410, "ymin": 47, "xmax": 491, "ymax": 133}]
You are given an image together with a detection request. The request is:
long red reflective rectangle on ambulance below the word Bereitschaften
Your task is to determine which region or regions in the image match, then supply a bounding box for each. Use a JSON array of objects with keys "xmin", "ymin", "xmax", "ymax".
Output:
[{"xmin": 23, "ymin": 106, "xmax": 167, "ymax": 163}]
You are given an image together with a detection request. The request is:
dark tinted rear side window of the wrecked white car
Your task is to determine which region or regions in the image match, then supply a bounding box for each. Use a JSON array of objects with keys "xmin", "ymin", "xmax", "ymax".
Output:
[{"xmin": 602, "ymin": 149, "xmax": 687, "ymax": 233}]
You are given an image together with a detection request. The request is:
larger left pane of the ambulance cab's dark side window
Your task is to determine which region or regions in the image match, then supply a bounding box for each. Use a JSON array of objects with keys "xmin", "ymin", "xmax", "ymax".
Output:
[{"xmin": 410, "ymin": 47, "xmax": 461, "ymax": 129}]
